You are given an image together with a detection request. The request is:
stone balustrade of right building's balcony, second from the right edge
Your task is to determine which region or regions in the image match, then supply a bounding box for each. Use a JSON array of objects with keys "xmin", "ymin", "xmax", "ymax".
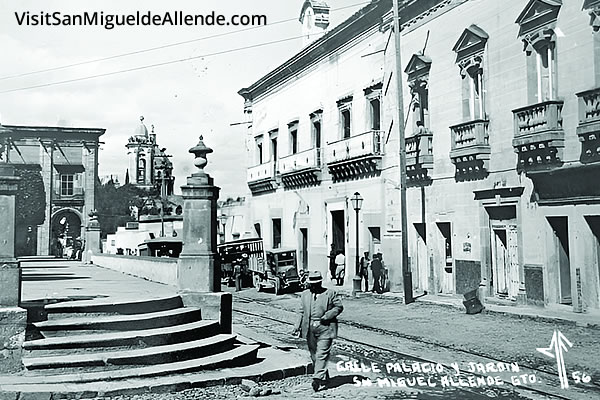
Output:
[{"xmin": 513, "ymin": 100, "xmax": 564, "ymax": 139}]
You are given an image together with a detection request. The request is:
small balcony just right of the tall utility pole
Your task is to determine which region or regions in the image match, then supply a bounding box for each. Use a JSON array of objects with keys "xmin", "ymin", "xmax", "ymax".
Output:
[{"xmin": 405, "ymin": 129, "xmax": 433, "ymax": 183}]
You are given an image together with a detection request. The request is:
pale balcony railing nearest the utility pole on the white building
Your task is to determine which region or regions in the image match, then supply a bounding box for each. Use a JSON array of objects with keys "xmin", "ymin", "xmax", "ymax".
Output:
[{"xmin": 327, "ymin": 130, "xmax": 383, "ymax": 164}]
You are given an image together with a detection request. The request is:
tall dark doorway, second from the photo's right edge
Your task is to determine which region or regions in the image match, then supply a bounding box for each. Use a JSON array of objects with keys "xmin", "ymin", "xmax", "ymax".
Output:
[{"xmin": 548, "ymin": 217, "xmax": 573, "ymax": 304}]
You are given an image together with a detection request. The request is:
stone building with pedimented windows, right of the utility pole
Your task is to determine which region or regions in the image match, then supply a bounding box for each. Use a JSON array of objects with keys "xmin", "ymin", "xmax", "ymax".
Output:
[{"xmin": 383, "ymin": 0, "xmax": 600, "ymax": 312}]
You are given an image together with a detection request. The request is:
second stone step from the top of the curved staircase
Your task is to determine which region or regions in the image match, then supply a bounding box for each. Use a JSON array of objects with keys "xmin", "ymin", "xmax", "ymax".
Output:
[{"xmin": 33, "ymin": 307, "xmax": 202, "ymax": 334}]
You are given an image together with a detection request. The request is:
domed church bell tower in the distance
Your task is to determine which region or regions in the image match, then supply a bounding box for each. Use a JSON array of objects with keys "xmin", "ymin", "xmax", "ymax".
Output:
[{"xmin": 125, "ymin": 117, "xmax": 175, "ymax": 196}]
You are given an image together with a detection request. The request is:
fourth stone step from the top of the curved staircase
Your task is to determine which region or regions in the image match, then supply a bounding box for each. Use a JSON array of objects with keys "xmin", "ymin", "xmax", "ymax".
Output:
[{"xmin": 23, "ymin": 334, "xmax": 236, "ymax": 370}]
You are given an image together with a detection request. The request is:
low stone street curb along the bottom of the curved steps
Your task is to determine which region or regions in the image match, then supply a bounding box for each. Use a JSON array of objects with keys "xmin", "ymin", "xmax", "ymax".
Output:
[{"xmin": 0, "ymin": 363, "xmax": 312, "ymax": 400}]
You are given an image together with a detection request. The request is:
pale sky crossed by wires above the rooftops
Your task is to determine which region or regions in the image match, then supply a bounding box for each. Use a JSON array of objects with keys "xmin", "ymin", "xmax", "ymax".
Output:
[{"xmin": 0, "ymin": 0, "xmax": 368, "ymax": 199}]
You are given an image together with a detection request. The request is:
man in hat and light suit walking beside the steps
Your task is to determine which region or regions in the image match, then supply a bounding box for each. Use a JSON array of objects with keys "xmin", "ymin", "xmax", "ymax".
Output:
[{"xmin": 293, "ymin": 271, "xmax": 344, "ymax": 392}]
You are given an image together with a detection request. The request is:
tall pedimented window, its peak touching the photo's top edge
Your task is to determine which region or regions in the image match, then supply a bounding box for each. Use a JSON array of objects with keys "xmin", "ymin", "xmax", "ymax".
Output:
[{"xmin": 516, "ymin": 0, "xmax": 562, "ymax": 103}]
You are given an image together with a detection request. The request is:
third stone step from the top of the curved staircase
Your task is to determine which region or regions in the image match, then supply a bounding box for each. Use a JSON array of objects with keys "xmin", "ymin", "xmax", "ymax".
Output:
[{"xmin": 23, "ymin": 320, "xmax": 220, "ymax": 350}]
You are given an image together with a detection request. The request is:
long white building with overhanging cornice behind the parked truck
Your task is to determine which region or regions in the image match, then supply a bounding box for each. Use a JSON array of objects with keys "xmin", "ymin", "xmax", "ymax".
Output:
[{"xmin": 239, "ymin": 0, "xmax": 399, "ymax": 285}]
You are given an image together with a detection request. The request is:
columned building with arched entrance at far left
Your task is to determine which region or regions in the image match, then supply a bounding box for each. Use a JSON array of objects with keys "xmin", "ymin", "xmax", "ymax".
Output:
[{"xmin": 0, "ymin": 125, "xmax": 105, "ymax": 255}]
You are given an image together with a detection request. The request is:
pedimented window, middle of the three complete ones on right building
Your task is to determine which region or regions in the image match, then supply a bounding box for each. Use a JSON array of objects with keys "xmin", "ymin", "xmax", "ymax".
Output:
[{"xmin": 452, "ymin": 25, "xmax": 489, "ymax": 121}]
